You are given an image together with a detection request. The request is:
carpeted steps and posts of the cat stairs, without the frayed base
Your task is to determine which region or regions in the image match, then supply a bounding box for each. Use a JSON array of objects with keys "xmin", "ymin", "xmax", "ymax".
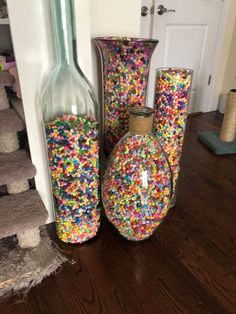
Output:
[{"xmin": 0, "ymin": 71, "xmax": 48, "ymax": 248}]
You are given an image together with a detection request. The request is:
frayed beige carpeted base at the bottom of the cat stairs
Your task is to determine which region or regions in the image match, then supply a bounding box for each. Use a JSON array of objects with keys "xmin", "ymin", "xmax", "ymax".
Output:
[{"xmin": 0, "ymin": 228, "xmax": 67, "ymax": 297}]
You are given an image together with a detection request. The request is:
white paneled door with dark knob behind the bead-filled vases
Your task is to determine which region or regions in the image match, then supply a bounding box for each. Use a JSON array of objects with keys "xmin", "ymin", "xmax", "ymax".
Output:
[{"xmin": 140, "ymin": 0, "xmax": 224, "ymax": 113}]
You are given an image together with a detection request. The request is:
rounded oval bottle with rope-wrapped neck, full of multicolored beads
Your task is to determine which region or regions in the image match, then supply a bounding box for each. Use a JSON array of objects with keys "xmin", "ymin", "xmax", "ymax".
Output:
[{"xmin": 102, "ymin": 107, "xmax": 172, "ymax": 241}]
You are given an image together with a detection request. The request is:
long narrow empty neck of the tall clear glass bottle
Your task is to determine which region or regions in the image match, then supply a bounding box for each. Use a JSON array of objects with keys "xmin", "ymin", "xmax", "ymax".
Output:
[{"xmin": 51, "ymin": 0, "xmax": 75, "ymax": 66}]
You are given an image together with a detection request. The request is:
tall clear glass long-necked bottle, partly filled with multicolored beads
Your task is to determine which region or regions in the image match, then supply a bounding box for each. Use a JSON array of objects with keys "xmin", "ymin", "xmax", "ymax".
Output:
[{"xmin": 42, "ymin": 0, "xmax": 100, "ymax": 243}]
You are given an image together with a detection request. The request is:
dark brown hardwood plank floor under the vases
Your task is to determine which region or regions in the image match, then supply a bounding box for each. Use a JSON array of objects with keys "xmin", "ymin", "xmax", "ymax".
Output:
[{"xmin": 0, "ymin": 113, "xmax": 236, "ymax": 314}]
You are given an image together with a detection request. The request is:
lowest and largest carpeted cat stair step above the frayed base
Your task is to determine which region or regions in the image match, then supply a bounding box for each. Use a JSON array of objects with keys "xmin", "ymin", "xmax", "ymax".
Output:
[{"xmin": 0, "ymin": 190, "xmax": 48, "ymax": 239}]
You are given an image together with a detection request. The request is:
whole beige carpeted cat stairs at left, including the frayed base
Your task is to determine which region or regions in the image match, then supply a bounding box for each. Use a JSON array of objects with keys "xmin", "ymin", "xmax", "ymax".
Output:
[{"xmin": 0, "ymin": 72, "xmax": 66, "ymax": 301}]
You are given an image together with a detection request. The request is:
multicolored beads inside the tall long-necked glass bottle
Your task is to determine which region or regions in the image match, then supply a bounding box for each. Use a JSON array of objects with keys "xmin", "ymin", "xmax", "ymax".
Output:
[{"xmin": 46, "ymin": 115, "xmax": 100, "ymax": 243}]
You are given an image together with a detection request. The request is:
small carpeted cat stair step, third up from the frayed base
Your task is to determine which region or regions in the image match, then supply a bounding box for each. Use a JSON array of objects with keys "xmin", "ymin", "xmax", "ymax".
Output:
[{"xmin": 0, "ymin": 109, "xmax": 25, "ymax": 134}]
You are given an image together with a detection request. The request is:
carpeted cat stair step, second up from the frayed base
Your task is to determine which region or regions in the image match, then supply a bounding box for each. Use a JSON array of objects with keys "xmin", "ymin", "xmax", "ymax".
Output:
[{"xmin": 0, "ymin": 150, "xmax": 36, "ymax": 185}]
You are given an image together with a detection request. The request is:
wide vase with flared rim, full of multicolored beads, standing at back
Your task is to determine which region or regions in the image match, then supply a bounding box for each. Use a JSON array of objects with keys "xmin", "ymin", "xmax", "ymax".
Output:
[{"xmin": 96, "ymin": 37, "xmax": 158, "ymax": 155}]
